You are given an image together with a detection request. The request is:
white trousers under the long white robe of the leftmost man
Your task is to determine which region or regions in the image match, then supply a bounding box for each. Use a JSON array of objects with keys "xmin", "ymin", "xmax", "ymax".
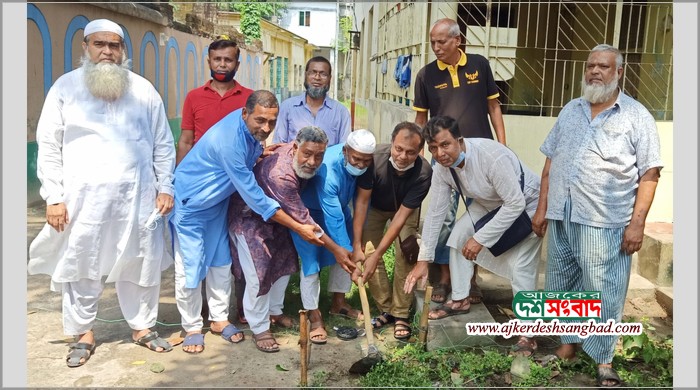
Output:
[{"xmin": 61, "ymin": 279, "xmax": 160, "ymax": 336}]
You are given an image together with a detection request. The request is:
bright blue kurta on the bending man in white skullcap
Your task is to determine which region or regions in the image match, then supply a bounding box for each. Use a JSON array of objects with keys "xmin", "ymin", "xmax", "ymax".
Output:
[{"xmin": 292, "ymin": 143, "xmax": 357, "ymax": 276}]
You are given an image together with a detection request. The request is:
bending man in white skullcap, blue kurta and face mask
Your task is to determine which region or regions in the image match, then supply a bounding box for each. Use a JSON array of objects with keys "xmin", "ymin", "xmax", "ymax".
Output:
[{"xmin": 292, "ymin": 130, "xmax": 376, "ymax": 344}]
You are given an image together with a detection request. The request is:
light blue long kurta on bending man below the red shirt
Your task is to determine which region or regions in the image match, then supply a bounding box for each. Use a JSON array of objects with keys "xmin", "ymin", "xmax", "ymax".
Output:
[{"xmin": 171, "ymin": 109, "xmax": 280, "ymax": 288}]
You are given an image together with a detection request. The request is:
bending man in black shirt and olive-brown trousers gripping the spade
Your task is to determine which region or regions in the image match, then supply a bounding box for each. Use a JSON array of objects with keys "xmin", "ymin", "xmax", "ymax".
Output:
[{"xmin": 352, "ymin": 122, "xmax": 432, "ymax": 340}]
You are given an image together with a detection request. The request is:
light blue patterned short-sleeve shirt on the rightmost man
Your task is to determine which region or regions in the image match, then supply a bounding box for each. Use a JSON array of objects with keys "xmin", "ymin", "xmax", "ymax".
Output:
[{"xmin": 540, "ymin": 92, "xmax": 662, "ymax": 228}]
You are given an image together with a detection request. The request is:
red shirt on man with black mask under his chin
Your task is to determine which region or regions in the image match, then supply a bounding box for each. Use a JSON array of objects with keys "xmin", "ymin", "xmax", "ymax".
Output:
[{"xmin": 180, "ymin": 80, "xmax": 253, "ymax": 143}]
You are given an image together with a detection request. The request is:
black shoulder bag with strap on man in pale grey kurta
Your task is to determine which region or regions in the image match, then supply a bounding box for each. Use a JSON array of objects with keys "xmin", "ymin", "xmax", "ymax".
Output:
[{"xmin": 450, "ymin": 164, "xmax": 532, "ymax": 257}]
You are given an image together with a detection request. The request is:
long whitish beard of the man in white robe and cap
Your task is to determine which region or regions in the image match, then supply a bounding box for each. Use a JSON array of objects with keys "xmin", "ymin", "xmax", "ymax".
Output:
[{"xmin": 80, "ymin": 55, "xmax": 131, "ymax": 102}]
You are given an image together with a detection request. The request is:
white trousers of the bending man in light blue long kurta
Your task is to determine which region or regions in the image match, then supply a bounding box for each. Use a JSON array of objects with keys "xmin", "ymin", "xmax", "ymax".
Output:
[{"xmin": 173, "ymin": 235, "xmax": 231, "ymax": 332}]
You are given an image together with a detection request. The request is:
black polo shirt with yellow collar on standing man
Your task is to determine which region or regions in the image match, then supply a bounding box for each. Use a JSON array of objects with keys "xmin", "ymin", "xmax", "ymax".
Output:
[{"xmin": 413, "ymin": 50, "xmax": 500, "ymax": 139}]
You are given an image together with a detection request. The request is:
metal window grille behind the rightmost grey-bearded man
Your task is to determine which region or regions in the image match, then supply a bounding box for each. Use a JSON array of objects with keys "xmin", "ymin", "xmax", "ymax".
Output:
[{"xmin": 445, "ymin": 1, "xmax": 673, "ymax": 120}]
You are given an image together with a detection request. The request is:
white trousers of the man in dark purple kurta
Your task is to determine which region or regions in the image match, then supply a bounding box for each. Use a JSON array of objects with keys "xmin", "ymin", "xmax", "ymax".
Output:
[{"xmin": 235, "ymin": 234, "xmax": 289, "ymax": 334}]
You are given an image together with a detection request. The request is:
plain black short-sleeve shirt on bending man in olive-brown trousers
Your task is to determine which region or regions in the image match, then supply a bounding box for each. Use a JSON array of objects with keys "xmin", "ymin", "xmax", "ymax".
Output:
[{"xmin": 357, "ymin": 144, "xmax": 433, "ymax": 212}]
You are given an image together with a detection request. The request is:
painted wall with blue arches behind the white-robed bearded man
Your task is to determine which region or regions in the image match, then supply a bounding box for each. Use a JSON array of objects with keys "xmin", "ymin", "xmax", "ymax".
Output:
[{"xmin": 27, "ymin": 3, "xmax": 263, "ymax": 203}]
